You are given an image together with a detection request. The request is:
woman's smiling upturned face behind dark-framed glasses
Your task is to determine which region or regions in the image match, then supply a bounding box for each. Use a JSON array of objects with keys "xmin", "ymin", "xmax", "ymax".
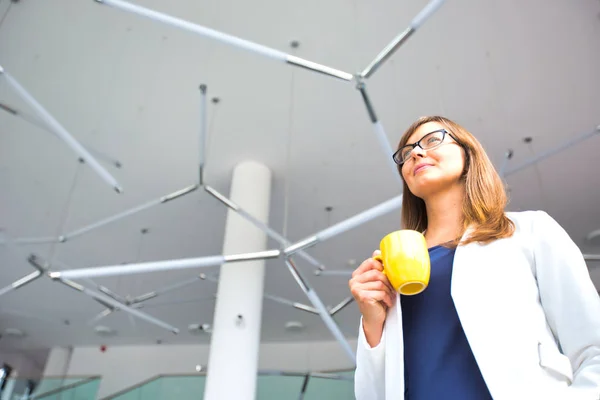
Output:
[{"xmin": 402, "ymin": 122, "xmax": 465, "ymax": 200}]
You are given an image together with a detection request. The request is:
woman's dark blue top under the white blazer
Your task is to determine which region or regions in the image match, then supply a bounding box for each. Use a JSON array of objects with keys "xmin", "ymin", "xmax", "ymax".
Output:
[{"xmin": 400, "ymin": 246, "xmax": 492, "ymax": 400}]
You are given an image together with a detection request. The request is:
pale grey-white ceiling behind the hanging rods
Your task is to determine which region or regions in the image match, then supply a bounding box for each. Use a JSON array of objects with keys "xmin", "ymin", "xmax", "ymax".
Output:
[{"xmin": 0, "ymin": 0, "xmax": 600, "ymax": 348}]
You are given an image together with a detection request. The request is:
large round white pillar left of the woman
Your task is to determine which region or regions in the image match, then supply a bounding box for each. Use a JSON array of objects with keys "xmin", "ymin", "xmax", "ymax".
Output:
[{"xmin": 204, "ymin": 161, "xmax": 271, "ymax": 400}]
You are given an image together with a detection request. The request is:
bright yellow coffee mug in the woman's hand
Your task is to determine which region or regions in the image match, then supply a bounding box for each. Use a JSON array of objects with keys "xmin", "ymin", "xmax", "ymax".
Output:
[{"xmin": 373, "ymin": 229, "xmax": 431, "ymax": 296}]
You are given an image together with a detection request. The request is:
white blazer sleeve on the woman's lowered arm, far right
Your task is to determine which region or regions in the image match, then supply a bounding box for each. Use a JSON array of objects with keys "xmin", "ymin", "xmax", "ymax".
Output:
[{"xmin": 533, "ymin": 211, "xmax": 600, "ymax": 395}]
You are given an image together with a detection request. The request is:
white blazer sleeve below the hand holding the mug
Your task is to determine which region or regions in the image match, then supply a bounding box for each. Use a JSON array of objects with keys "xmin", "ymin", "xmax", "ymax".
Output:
[{"xmin": 354, "ymin": 317, "xmax": 385, "ymax": 400}]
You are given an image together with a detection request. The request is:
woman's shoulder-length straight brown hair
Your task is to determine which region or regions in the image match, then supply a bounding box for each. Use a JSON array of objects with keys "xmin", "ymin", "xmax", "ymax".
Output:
[{"xmin": 398, "ymin": 116, "xmax": 515, "ymax": 247}]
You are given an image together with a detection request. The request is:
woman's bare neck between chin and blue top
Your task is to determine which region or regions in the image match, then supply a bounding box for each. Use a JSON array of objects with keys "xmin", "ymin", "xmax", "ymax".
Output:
[{"xmin": 425, "ymin": 185, "xmax": 464, "ymax": 247}]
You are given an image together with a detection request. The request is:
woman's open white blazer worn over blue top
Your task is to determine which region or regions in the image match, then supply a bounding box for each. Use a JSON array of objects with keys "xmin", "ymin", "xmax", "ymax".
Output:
[{"xmin": 354, "ymin": 211, "xmax": 600, "ymax": 400}]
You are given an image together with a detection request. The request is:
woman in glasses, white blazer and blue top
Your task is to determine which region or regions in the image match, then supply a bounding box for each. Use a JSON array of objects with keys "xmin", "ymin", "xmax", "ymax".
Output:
[{"xmin": 349, "ymin": 117, "xmax": 600, "ymax": 400}]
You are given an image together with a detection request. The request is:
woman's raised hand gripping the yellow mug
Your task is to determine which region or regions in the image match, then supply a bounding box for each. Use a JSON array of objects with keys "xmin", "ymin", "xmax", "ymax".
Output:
[{"xmin": 348, "ymin": 250, "xmax": 396, "ymax": 347}]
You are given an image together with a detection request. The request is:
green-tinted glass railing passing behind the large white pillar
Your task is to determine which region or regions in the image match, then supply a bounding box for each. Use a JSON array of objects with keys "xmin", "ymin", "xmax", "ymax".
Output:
[{"xmin": 102, "ymin": 371, "xmax": 354, "ymax": 400}]
